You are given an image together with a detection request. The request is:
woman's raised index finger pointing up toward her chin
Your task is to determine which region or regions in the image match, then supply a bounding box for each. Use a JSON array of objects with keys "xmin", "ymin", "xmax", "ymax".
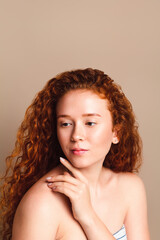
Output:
[{"xmin": 60, "ymin": 157, "xmax": 86, "ymax": 182}]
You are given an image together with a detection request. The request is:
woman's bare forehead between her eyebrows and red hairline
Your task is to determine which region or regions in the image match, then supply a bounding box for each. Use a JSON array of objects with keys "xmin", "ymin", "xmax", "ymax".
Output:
[{"xmin": 56, "ymin": 89, "xmax": 108, "ymax": 114}]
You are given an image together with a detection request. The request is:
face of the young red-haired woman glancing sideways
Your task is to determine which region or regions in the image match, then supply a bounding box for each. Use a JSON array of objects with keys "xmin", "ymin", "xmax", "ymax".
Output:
[{"xmin": 56, "ymin": 90, "xmax": 116, "ymax": 168}]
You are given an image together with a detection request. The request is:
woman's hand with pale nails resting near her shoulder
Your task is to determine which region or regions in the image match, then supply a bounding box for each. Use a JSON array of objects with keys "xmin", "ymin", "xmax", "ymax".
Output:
[{"xmin": 46, "ymin": 158, "xmax": 93, "ymax": 222}]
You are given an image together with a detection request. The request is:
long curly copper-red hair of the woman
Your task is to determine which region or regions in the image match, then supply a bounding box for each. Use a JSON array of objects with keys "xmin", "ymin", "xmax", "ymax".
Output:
[{"xmin": 0, "ymin": 68, "xmax": 142, "ymax": 240}]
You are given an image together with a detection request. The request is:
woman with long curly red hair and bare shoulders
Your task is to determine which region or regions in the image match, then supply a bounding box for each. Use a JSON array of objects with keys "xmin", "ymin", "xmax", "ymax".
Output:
[{"xmin": 1, "ymin": 68, "xmax": 149, "ymax": 240}]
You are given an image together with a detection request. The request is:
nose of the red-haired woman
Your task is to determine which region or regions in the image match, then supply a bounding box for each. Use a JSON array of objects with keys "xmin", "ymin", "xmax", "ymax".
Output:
[{"xmin": 71, "ymin": 124, "xmax": 85, "ymax": 142}]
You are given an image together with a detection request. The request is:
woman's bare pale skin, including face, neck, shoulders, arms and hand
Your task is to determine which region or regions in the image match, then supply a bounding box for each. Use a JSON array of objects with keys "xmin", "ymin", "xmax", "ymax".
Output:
[{"xmin": 12, "ymin": 90, "xmax": 150, "ymax": 240}]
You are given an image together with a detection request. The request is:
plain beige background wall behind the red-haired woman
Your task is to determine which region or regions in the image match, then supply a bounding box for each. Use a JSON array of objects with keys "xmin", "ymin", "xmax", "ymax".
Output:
[{"xmin": 0, "ymin": 0, "xmax": 160, "ymax": 240}]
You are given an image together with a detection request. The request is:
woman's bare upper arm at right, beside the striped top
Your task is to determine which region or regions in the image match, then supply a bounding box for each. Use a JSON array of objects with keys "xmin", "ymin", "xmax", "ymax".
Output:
[{"xmin": 125, "ymin": 175, "xmax": 150, "ymax": 240}]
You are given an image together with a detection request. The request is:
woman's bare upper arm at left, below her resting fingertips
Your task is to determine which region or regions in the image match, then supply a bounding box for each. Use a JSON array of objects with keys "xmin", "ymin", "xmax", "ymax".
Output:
[{"xmin": 12, "ymin": 185, "xmax": 59, "ymax": 240}]
